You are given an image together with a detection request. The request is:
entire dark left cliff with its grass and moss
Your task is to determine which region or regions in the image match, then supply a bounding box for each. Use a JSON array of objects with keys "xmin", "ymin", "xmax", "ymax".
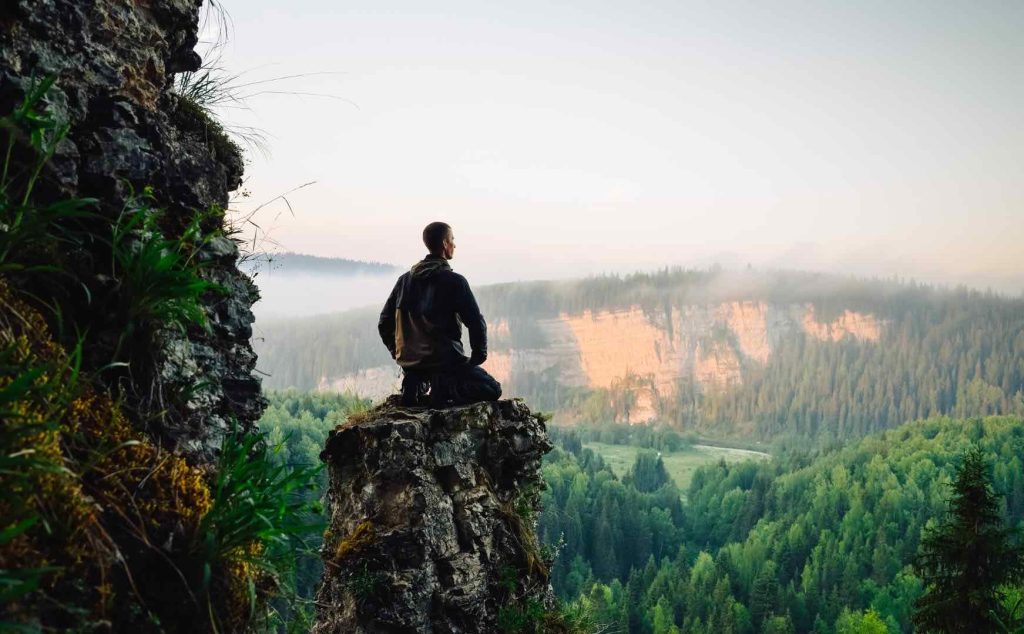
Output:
[{"xmin": 0, "ymin": 0, "xmax": 269, "ymax": 632}]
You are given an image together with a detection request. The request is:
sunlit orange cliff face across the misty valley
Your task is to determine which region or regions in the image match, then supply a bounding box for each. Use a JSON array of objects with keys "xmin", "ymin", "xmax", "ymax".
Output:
[{"xmin": 319, "ymin": 301, "xmax": 884, "ymax": 423}]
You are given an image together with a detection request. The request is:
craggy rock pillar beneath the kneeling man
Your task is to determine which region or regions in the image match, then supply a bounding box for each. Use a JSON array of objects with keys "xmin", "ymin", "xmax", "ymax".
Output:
[{"xmin": 312, "ymin": 399, "xmax": 553, "ymax": 634}]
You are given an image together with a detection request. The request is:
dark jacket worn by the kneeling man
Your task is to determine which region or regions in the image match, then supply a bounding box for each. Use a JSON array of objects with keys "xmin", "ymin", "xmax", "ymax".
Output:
[{"xmin": 377, "ymin": 255, "xmax": 487, "ymax": 370}]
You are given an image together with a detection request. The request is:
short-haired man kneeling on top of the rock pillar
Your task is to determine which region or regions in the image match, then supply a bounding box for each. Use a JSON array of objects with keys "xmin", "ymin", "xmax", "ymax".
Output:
[{"xmin": 377, "ymin": 222, "xmax": 502, "ymax": 407}]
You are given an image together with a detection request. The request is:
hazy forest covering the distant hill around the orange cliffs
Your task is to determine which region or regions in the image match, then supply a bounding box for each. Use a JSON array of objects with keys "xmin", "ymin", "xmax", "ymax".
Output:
[{"xmin": 256, "ymin": 270, "xmax": 1024, "ymax": 446}]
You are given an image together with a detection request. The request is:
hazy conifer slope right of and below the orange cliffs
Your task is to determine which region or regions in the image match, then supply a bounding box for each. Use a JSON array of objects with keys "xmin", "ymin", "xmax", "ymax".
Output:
[{"xmin": 677, "ymin": 291, "xmax": 1024, "ymax": 446}]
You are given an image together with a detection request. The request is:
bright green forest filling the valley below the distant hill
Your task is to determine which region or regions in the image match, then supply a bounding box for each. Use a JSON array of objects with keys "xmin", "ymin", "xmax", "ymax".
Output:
[{"xmin": 261, "ymin": 391, "xmax": 1024, "ymax": 634}]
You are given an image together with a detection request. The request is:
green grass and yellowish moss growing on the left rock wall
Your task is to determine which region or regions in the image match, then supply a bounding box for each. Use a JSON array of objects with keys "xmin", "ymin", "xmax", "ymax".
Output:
[{"xmin": 0, "ymin": 80, "xmax": 323, "ymax": 632}]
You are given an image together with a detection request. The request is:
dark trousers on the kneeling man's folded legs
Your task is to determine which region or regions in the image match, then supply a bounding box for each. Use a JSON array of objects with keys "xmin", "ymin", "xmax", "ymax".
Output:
[{"xmin": 401, "ymin": 364, "xmax": 502, "ymax": 408}]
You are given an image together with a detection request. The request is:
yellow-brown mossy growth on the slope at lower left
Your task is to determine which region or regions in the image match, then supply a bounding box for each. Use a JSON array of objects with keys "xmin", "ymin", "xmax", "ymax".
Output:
[{"xmin": 0, "ymin": 279, "xmax": 216, "ymax": 629}]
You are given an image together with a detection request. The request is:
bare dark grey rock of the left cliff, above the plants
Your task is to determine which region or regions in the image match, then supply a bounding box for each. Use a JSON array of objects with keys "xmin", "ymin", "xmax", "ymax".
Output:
[{"xmin": 0, "ymin": 0, "xmax": 264, "ymax": 462}]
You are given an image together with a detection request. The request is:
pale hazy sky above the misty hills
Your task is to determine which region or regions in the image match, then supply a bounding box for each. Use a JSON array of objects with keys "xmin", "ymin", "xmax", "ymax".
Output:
[{"xmin": 209, "ymin": 0, "xmax": 1024, "ymax": 293}]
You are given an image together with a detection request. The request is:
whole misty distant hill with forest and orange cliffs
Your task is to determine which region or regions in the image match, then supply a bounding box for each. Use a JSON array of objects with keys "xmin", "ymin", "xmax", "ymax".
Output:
[{"xmin": 256, "ymin": 269, "xmax": 1024, "ymax": 441}]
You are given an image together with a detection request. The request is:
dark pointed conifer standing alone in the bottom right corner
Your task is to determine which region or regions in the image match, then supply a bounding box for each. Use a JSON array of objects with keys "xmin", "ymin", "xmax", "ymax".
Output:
[{"xmin": 913, "ymin": 446, "xmax": 1024, "ymax": 632}]
